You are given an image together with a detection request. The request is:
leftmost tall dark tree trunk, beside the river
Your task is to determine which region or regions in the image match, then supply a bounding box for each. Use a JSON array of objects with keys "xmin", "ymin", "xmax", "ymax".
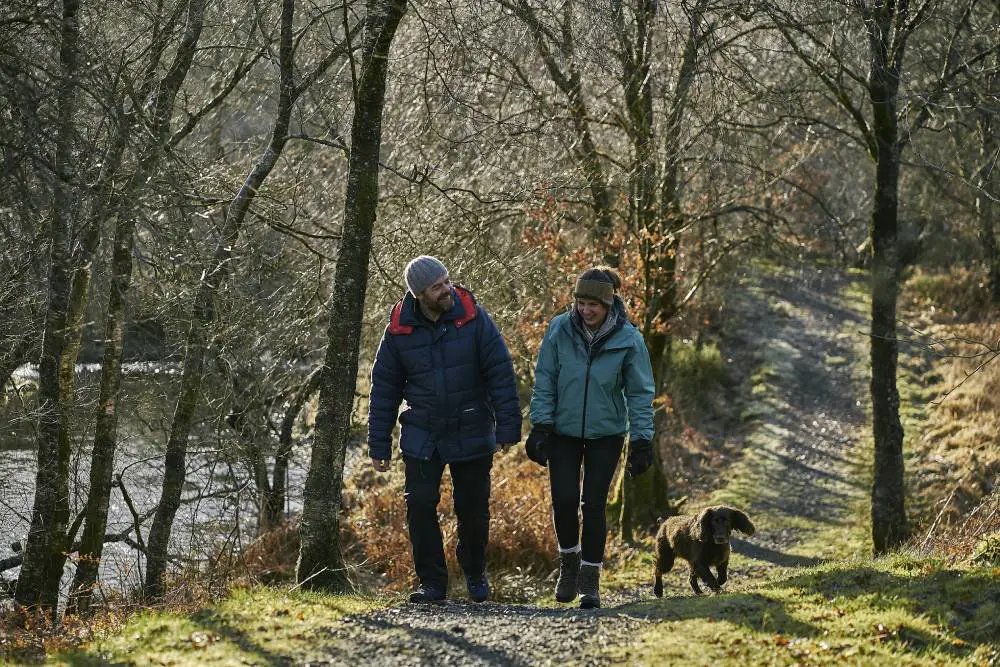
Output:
[{"xmin": 14, "ymin": 0, "xmax": 80, "ymax": 615}]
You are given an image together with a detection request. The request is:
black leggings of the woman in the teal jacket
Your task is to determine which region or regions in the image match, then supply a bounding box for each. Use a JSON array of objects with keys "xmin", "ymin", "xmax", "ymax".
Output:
[{"xmin": 546, "ymin": 434, "xmax": 625, "ymax": 563}]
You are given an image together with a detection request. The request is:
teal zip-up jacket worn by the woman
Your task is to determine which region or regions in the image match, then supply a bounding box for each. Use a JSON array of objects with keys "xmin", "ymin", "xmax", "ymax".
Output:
[{"xmin": 531, "ymin": 296, "xmax": 655, "ymax": 440}]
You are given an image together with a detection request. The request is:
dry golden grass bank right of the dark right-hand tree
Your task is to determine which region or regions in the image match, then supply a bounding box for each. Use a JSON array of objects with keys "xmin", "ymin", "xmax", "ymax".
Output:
[{"xmin": 900, "ymin": 268, "xmax": 1000, "ymax": 554}]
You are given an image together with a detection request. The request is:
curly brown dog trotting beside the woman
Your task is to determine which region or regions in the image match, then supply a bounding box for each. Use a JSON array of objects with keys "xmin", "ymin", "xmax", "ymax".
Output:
[{"xmin": 653, "ymin": 505, "xmax": 754, "ymax": 597}]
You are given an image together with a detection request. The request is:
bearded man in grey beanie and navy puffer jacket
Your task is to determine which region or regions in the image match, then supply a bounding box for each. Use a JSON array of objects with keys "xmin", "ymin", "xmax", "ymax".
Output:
[{"xmin": 368, "ymin": 255, "xmax": 521, "ymax": 602}]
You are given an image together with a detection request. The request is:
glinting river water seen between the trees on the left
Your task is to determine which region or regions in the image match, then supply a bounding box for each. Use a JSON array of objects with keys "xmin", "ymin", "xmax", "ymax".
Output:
[{"xmin": 0, "ymin": 363, "xmax": 309, "ymax": 594}]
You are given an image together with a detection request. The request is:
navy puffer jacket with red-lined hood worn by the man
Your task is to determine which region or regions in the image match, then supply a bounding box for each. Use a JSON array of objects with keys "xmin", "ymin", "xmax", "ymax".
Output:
[{"xmin": 368, "ymin": 286, "xmax": 521, "ymax": 463}]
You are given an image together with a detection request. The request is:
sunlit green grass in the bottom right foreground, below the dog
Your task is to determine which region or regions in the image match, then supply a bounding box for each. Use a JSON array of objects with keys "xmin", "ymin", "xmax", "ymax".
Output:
[{"xmin": 614, "ymin": 555, "xmax": 1000, "ymax": 665}]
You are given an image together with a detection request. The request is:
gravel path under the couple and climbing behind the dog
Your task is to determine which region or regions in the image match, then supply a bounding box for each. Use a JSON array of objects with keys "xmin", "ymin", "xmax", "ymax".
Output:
[{"xmin": 309, "ymin": 267, "xmax": 863, "ymax": 666}]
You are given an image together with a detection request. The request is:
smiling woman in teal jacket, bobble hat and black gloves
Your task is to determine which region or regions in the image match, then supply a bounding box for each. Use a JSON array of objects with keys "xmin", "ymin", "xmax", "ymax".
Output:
[{"xmin": 525, "ymin": 267, "xmax": 654, "ymax": 609}]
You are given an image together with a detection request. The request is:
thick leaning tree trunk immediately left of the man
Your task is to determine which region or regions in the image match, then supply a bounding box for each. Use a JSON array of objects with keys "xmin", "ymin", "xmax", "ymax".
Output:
[{"xmin": 296, "ymin": 0, "xmax": 406, "ymax": 591}]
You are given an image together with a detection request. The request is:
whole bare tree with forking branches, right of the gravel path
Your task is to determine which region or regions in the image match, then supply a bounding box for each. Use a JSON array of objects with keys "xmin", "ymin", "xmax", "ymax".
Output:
[{"xmin": 762, "ymin": 0, "xmax": 992, "ymax": 554}]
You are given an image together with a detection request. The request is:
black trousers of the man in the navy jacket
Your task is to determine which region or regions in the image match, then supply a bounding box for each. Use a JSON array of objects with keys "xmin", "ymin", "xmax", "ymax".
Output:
[{"xmin": 404, "ymin": 452, "xmax": 493, "ymax": 591}]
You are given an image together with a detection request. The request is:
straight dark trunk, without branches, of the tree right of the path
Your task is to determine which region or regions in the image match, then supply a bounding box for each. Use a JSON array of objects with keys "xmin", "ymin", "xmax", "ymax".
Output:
[{"xmin": 868, "ymin": 16, "xmax": 909, "ymax": 554}]
